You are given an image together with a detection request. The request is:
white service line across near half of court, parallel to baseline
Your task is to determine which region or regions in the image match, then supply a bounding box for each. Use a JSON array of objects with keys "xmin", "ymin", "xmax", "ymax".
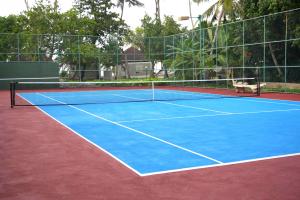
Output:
[{"xmin": 118, "ymin": 108, "xmax": 300, "ymax": 123}]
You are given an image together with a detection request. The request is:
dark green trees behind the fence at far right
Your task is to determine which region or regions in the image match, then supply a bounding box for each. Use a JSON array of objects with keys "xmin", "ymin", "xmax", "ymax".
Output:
[{"xmin": 240, "ymin": 0, "xmax": 300, "ymax": 81}]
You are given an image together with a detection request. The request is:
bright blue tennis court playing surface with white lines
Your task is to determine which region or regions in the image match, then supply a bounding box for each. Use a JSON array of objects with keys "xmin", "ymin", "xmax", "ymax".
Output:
[{"xmin": 18, "ymin": 89, "xmax": 300, "ymax": 176}]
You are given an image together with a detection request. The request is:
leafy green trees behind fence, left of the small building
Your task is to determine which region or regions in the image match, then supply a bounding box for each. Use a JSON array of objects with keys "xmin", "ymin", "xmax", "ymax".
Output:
[{"xmin": 0, "ymin": 0, "xmax": 128, "ymax": 78}]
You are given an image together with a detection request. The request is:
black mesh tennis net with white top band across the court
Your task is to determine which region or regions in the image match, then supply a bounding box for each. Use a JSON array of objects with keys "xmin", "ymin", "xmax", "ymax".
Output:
[{"xmin": 10, "ymin": 78, "xmax": 260, "ymax": 107}]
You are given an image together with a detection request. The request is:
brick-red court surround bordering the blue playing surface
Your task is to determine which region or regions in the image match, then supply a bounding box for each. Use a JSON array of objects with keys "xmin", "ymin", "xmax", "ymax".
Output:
[{"xmin": 0, "ymin": 91, "xmax": 300, "ymax": 200}]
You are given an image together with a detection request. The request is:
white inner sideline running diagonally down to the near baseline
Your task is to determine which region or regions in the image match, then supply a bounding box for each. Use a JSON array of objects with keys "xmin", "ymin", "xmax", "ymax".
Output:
[{"xmin": 39, "ymin": 94, "xmax": 223, "ymax": 164}]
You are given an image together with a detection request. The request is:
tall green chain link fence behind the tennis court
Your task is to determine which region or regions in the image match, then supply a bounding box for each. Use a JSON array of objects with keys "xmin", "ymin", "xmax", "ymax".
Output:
[{"xmin": 0, "ymin": 8, "xmax": 300, "ymax": 93}]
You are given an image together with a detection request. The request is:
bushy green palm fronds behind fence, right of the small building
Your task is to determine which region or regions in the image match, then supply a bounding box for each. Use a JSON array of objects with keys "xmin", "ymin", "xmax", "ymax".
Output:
[{"xmin": 164, "ymin": 23, "xmax": 229, "ymax": 79}]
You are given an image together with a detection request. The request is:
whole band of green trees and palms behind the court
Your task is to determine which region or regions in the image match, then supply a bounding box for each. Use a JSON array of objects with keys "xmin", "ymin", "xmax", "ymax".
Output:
[{"xmin": 0, "ymin": 0, "xmax": 300, "ymax": 81}]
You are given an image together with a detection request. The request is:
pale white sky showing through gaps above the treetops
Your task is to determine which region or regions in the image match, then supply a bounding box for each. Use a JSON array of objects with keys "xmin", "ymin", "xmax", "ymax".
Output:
[{"xmin": 0, "ymin": 0, "xmax": 216, "ymax": 29}]
